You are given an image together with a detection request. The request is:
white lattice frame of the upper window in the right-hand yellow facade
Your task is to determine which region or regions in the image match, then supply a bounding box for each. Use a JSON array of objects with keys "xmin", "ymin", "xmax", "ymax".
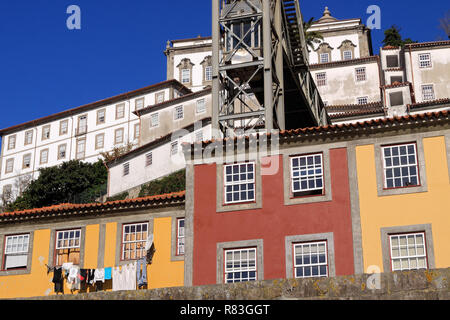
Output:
[{"xmin": 381, "ymin": 143, "xmax": 421, "ymax": 189}]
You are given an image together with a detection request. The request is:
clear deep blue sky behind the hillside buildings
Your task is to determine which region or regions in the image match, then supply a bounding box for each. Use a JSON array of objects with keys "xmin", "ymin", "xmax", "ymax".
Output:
[{"xmin": 0, "ymin": 0, "xmax": 450, "ymax": 128}]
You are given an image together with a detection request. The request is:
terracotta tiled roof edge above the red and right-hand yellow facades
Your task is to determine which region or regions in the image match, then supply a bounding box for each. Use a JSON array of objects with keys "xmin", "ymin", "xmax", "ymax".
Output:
[{"xmin": 183, "ymin": 110, "xmax": 450, "ymax": 152}]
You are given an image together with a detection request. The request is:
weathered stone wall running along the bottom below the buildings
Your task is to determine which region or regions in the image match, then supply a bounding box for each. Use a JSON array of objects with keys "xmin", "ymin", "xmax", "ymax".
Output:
[{"xmin": 19, "ymin": 268, "xmax": 450, "ymax": 300}]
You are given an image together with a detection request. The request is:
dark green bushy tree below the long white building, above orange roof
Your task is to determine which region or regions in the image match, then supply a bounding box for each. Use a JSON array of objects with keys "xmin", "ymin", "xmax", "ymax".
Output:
[{"xmin": 6, "ymin": 160, "xmax": 108, "ymax": 211}]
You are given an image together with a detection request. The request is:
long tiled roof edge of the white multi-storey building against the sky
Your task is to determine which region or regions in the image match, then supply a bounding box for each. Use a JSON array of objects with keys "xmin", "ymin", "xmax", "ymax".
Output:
[{"xmin": 0, "ymin": 79, "xmax": 192, "ymax": 136}]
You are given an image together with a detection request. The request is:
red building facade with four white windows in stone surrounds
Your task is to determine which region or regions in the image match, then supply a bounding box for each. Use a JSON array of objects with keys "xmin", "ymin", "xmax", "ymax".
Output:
[{"xmin": 185, "ymin": 131, "xmax": 362, "ymax": 285}]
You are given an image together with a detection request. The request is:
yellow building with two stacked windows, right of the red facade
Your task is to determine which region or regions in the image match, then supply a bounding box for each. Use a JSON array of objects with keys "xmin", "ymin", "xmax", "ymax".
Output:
[{"xmin": 354, "ymin": 111, "xmax": 450, "ymax": 273}]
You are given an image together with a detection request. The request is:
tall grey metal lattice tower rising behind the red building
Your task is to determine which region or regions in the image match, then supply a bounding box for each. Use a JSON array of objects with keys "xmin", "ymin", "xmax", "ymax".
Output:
[{"xmin": 212, "ymin": 0, "xmax": 329, "ymax": 138}]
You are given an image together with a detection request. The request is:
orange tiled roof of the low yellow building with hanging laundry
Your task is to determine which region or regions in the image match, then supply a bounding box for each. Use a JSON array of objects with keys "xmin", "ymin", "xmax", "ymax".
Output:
[{"xmin": 0, "ymin": 191, "xmax": 186, "ymax": 222}]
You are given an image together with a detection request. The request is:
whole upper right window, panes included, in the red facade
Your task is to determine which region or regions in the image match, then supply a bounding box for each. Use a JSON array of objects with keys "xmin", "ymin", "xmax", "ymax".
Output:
[{"xmin": 291, "ymin": 153, "xmax": 324, "ymax": 196}]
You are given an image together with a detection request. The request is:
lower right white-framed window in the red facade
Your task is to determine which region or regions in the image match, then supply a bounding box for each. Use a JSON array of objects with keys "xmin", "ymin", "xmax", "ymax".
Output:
[{"xmin": 293, "ymin": 241, "xmax": 328, "ymax": 278}]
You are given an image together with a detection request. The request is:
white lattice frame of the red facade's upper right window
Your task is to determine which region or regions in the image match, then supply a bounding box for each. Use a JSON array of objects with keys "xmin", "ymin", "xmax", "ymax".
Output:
[{"xmin": 290, "ymin": 153, "xmax": 325, "ymax": 195}]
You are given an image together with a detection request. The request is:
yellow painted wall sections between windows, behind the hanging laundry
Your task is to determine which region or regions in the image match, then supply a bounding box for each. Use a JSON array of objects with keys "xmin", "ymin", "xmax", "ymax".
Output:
[{"xmin": 0, "ymin": 217, "xmax": 184, "ymax": 299}]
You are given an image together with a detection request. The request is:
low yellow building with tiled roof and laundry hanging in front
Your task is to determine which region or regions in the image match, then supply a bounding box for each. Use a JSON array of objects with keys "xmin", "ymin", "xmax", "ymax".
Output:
[{"xmin": 0, "ymin": 192, "xmax": 185, "ymax": 299}]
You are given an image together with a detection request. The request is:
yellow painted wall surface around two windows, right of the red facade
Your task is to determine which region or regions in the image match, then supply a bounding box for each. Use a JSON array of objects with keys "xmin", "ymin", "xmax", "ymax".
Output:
[{"xmin": 356, "ymin": 137, "xmax": 450, "ymax": 272}]
